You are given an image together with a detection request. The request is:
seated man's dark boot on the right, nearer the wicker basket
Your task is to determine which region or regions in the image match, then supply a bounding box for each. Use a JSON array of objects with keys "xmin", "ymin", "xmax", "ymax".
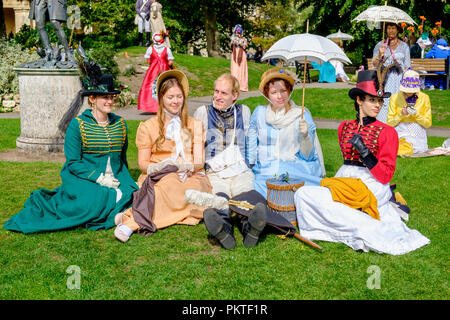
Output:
[{"xmin": 241, "ymin": 202, "xmax": 267, "ymax": 247}]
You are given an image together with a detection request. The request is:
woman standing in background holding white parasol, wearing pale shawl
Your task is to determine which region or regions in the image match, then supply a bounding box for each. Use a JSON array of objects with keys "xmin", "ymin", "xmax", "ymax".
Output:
[{"xmin": 372, "ymin": 23, "xmax": 411, "ymax": 123}]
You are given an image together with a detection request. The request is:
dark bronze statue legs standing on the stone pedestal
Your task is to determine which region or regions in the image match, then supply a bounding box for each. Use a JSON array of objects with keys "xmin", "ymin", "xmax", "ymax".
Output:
[{"xmin": 28, "ymin": 0, "xmax": 76, "ymax": 67}]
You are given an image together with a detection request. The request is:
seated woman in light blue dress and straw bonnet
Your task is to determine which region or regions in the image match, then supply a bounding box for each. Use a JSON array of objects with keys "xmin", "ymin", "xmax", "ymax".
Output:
[{"xmin": 246, "ymin": 68, "xmax": 325, "ymax": 198}]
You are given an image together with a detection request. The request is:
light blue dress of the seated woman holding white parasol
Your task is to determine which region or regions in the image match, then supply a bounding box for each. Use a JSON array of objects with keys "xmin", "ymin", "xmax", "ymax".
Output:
[{"xmin": 246, "ymin": 105, "xmax": 323, "ymax": 198}]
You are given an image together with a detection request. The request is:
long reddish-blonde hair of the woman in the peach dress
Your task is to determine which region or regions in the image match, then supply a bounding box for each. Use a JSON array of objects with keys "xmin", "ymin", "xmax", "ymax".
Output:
[{"xmin": 155, "ymin": 77, "xmax": 191, "ymax": 149}]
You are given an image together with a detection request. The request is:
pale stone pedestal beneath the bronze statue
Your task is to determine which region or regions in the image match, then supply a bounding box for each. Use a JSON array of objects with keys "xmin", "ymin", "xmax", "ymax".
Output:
[{"xmin": 14, "ymin": 67, "xmax": 87, "ymax": 154}]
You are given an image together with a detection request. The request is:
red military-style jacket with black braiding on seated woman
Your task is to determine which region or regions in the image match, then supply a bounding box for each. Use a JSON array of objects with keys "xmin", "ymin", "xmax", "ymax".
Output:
[{"xmin": 338, "ymin": 117, "xmax": 398, "ymax": 184}]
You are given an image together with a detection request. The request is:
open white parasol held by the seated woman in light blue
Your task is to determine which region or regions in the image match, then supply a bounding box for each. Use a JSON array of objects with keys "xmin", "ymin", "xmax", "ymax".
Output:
[{"xmin": 261, "ymin": 20, "xmax": 352, "ymax": 118}]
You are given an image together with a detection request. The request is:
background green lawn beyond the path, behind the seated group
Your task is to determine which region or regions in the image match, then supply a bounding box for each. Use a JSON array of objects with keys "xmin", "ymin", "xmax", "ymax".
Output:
[{"xmin": 117, "ymin": 46, "xmax": 450, "ymax": 127}]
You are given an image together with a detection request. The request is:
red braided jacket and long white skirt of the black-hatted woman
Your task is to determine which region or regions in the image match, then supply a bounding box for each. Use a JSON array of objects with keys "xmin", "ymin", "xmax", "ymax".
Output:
[{"xmin": 295, "ymin": 117, "xmax": 430, "ymax": 255}]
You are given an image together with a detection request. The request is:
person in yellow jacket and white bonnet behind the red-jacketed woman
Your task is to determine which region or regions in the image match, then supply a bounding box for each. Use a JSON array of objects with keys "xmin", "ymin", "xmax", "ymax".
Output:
[{"xmin": 387, "ymin": 70, "xmax": 432, "ymax": 155}]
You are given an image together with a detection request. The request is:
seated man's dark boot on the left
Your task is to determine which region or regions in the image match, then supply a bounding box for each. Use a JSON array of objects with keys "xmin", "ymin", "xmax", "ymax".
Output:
[{"xmin": 203, "ymin": 208, "xmax": 236, "ymax": 249}]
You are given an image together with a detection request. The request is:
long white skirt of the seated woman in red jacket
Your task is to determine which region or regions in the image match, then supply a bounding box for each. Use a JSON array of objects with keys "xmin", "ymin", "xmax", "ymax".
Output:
[{"xmin": 294, "ymin": 165, "xmax": 430, "ymax": 255}]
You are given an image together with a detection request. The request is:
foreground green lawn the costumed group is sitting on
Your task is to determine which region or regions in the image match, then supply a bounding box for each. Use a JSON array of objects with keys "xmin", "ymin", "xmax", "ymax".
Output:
[{"xmin": 0, "ymin": 119, "xmax": 450, "ymax": 300}]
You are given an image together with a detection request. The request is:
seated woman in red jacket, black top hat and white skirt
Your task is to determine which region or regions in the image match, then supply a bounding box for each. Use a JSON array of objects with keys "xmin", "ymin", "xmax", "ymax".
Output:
[{"xmin": 294, "ymin": 70, "xmax": 430, "ymax": 255}]
